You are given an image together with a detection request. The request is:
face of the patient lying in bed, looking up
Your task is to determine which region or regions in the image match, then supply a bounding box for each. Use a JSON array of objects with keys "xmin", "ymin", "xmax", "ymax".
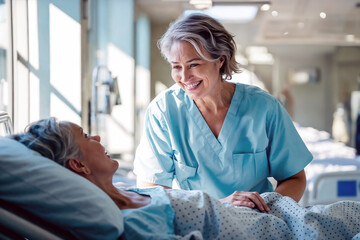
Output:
[{"xmin": 71, "ymin": 123, "xmax": 119, "ymax": 177}]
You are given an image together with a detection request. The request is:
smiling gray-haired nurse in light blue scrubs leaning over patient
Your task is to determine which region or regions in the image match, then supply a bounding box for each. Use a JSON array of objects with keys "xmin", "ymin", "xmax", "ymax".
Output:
[{"xmin": 134, "ymin": 14, "xmax": 312, "ymax": 211}]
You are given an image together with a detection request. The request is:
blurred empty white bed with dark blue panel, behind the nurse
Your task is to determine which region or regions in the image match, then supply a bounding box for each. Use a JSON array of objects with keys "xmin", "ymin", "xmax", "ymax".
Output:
[{"xmin": 295, "ymin": 124, "xmax": 360, "ymax": 206}]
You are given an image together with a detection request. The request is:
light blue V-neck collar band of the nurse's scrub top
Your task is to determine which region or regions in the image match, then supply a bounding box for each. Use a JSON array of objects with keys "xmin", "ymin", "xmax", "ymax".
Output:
[{"xmin": 188, "ymin": 84, "xmax": 241, "ymax": 154}]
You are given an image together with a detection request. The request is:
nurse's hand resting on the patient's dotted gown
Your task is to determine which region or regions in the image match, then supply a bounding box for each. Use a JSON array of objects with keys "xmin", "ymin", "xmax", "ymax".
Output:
[{"xmin": 220, "ymin": 191, "xmax": 270, "ymax": 212}]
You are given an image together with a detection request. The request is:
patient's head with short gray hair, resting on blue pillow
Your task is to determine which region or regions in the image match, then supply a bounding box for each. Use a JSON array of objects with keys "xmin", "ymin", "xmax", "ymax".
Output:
[{"xmin": 11, "ymin": 117, "xmax": 118, "ymax": 186}]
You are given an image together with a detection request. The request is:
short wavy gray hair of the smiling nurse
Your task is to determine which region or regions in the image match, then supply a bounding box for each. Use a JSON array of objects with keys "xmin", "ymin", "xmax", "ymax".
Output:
[{"xmin": 157, "ymin": 14, "xmax": 240, "ymax": 80}]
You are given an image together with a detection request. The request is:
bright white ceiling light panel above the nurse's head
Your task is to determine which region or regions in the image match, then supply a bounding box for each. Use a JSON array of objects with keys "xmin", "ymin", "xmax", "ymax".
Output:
[{"xmin": 184, "ymin": 6, "xmax": 258, "ymax": 23}]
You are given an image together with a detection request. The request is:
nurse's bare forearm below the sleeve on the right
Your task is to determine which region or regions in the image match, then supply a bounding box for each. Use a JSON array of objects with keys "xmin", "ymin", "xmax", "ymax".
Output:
[{"xmin": 275, "ymin": 170, "xmax": 306, "ymax": 202}]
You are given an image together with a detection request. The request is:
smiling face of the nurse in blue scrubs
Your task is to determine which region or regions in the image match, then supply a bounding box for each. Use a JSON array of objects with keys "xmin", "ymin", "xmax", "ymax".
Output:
[{"xmin": 169, "ymin": 41, "xmax": 223, "ymax": 100}]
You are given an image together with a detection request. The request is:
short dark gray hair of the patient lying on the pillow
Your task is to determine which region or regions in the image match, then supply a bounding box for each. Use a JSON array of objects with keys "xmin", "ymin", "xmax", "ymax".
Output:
[{"xmin": 10, "ymin": 117, "xmax": 81, "ymax": 167}]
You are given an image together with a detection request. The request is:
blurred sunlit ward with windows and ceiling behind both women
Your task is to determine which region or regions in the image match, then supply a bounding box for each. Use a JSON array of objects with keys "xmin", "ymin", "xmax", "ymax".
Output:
[{"xmin": 0, "ymin": 0, "xmax": 360, "ymax": 184}]
